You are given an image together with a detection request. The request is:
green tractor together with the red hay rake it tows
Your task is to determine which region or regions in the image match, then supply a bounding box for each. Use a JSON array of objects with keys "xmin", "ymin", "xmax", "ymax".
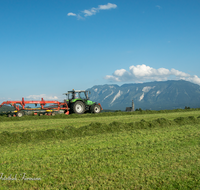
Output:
[{"xmin": 0, "ymin": 89, "xmax": 103, "ymax": 117}]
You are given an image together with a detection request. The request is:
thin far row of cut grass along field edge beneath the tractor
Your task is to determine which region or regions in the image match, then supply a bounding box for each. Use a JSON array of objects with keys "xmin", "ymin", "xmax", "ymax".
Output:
[{"xmin": 0, "ymin": 108, "xmax": 200, "ymax": 122}]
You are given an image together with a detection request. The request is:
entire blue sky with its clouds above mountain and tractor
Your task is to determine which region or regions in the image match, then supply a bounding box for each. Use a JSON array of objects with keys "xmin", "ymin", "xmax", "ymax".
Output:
[{"xmin": 0, "ymin": 0, "xmax": 200, "ymax": 102}]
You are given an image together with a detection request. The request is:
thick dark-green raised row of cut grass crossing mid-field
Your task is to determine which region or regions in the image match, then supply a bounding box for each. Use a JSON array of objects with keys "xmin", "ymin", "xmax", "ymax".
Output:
[{"xmin": 0, "ymin": 116, "xmax": 200, "ymax": 145}]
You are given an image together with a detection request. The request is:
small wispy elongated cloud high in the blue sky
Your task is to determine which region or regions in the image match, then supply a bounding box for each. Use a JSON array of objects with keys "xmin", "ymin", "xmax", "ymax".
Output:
[{"xmin": 67, "ymin": 3, "xmax": 117, "ymax": 19}]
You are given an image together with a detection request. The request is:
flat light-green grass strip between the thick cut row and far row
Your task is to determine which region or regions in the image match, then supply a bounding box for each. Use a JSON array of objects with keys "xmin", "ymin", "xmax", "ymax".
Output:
[{"xmin": 0, "ymin": 111, "xmax": 200, "ymax": 133}]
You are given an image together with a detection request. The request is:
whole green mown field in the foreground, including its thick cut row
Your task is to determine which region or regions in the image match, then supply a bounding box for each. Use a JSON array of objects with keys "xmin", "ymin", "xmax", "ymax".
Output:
[{"xmin": 0, "ymin": 111, "xmax": 200, "ymax": 190}]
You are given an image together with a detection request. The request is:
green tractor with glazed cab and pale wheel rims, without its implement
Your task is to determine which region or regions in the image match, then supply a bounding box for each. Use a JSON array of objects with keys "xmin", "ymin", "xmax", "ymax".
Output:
[{"xmin": 65, "ymin": 89, "xmax": 103, "ymax": 114}]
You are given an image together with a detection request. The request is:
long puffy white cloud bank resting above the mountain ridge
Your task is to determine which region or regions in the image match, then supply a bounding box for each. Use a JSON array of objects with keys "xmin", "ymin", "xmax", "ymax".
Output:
[{"xmin": 105, "ymin": 64, "xmax": 200, "ymax": 85}]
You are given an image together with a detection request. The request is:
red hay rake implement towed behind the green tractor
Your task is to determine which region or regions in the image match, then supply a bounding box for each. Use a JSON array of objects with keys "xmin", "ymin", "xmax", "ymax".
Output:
[{"xmin": 0, "ymin": 98, "xmax": 69, "ymax": 117}]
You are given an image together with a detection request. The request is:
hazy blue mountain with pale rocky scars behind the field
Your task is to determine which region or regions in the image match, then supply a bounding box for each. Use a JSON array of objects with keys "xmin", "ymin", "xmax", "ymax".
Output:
[{"xmin": 87, "ymin": 80, "xmax": 200, "ymax": 110}]
